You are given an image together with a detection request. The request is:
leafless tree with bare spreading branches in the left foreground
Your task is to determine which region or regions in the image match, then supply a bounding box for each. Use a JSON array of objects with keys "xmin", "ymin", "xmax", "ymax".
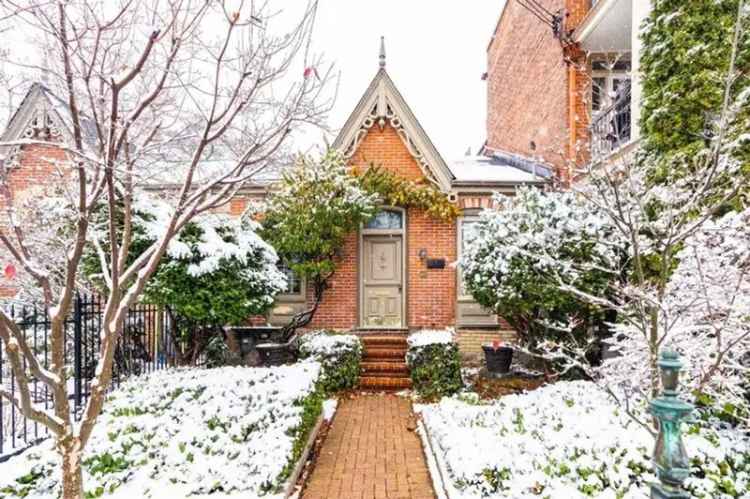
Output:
[{"xmin": 0, "ymin": 0, "xmax": 330, "ymax": 498}]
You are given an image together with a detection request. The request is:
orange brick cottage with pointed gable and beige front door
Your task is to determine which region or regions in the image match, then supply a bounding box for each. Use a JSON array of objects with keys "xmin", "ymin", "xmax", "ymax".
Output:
[{"xmin": 0, "ymin": 40, "xmax": 551, "ymax": 360}]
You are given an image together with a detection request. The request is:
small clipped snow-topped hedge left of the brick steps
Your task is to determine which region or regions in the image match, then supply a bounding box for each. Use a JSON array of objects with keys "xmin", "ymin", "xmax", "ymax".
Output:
[{"xmin": 299, "ymin": 331, "xmax": 362, "ymax": 393}]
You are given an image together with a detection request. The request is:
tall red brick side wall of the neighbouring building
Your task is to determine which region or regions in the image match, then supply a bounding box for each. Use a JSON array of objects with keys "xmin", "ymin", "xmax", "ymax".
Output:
[{"xmin": 487, "ymin": 0, "xmax": 591, "ymax": 180}]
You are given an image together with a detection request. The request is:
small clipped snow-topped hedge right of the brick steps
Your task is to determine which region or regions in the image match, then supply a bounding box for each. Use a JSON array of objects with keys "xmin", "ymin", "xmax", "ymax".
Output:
[{"xmin": 406, "ymin": 329, "xmax": 463, "ymax": 399}]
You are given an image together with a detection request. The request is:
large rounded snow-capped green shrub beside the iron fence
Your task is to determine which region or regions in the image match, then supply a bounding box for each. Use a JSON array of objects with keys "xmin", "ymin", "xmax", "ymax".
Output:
[{"xmin": 144, "ymin": 214, "xmax": 286, "ymax": 365}]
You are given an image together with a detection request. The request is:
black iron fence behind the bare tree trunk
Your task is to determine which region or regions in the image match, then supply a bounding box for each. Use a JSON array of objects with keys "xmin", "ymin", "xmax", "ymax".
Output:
[{"xmin": 0, "ymin": 295, "xmax": 177, "ymax": 460}]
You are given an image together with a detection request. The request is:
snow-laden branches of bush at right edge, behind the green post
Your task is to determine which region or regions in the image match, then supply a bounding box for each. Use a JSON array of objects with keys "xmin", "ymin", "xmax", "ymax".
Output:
[{"xmin": 602, "ymin": 210, "xmax": 750, "ymax": 413}]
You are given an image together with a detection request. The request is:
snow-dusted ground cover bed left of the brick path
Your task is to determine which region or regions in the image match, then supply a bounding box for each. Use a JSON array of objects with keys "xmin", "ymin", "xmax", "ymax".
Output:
[{"xmin": 0, "ymin": 362, "xmax": 330, "ymax": 499}]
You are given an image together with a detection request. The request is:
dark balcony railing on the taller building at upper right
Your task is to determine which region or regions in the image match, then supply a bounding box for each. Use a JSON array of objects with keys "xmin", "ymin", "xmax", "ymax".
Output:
[{"xmin": 591, "ymin": 82, "xmax": 630, "ymax": 160}]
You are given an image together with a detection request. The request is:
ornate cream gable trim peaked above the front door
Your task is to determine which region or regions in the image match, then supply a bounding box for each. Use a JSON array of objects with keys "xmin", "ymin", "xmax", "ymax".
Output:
[{"xmin": 333, "ymin": 66, "xmax": 454, "ymax": 192}]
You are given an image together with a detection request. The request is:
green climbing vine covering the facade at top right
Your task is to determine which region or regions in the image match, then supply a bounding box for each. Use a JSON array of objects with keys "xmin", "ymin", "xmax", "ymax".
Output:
[{"xmin": 641, "ymin": 0, "xmax": 750, "ymax": 181}]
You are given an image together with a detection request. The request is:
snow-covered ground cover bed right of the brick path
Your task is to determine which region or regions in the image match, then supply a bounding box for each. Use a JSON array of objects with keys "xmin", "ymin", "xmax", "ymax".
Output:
[{"xmin": 416, "ymin": 381, "xmax": 750, "ymax": 499}]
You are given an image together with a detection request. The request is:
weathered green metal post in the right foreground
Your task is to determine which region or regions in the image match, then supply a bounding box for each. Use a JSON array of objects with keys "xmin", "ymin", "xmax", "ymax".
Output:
[{"xmin": 650, "ymin": 350, "xmax": 693, "ymax": 499}]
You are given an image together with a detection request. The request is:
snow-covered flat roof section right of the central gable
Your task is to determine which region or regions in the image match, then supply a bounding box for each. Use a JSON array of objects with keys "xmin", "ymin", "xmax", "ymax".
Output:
[{"xmin": 448, "ymin": 156, "xmax": 549, "ymax": 184}]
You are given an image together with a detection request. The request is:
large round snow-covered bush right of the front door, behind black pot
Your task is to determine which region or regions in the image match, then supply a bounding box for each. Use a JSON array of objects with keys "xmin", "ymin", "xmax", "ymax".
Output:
[{"xmin": 459, "ymin": 188, "xmax": 624, "ymax": 368}]
